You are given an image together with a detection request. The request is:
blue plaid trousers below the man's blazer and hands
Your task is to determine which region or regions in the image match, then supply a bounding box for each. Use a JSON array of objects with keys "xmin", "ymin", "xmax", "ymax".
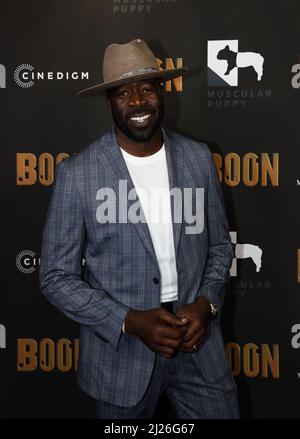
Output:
[{"xmin": 96, "ymin": 352, "xmax": 239, "ymax": 419}]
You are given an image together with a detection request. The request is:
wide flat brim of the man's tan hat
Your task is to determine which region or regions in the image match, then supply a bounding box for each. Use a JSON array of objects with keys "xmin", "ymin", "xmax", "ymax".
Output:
[{"xmin": 77, "ymin": 67, "xmax": 187, "ymax": 97}]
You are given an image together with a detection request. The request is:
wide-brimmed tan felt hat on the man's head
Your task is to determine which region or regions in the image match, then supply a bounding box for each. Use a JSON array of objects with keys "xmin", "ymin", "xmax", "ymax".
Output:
[{"xmin": 77, "ymin": 38, "xmax": 187, "ymax": 97}]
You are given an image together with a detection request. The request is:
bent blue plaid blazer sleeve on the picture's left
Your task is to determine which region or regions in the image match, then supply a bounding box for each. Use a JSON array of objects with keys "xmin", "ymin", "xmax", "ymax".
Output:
[{"xmin": 40, "ymin": 159, "xmax": 129, "ymax": 349}]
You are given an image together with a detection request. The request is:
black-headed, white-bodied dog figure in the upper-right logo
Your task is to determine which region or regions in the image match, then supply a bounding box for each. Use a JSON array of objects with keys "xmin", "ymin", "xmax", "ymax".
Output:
[{"xmin": 217, "ymin": 44, "xmax": 264, "ymax": 81}]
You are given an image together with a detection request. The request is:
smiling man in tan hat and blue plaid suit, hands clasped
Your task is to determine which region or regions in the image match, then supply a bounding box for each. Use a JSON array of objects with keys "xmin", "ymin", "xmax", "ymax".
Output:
[{"xmin": 40, "ymin": 39, "xmax": 238, "ymax": 419}]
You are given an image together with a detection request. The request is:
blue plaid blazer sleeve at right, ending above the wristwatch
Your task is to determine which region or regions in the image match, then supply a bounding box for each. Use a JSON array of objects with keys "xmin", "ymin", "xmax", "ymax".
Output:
[{"xmin": 196, "ymin": 150, "xmax": 233, "ymax": 310}]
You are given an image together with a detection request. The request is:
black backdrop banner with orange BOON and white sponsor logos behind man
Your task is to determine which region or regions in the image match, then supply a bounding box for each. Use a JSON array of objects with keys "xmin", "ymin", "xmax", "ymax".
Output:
[{"xmin": 0, "ymin": 0, "xmax": 300, "ymax": 419}]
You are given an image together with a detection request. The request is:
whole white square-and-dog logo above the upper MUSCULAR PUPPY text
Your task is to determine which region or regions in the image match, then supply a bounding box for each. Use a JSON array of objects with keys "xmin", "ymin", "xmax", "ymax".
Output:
[{"xmin": 207, "ymin": 40, "xmax": 264, "ymax": 87}]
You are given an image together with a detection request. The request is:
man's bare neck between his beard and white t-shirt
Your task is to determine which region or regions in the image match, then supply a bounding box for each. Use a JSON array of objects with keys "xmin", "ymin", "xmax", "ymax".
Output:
[{"xmin": 115, "ymin": 126, "xmax": 163, "ymax": 157}]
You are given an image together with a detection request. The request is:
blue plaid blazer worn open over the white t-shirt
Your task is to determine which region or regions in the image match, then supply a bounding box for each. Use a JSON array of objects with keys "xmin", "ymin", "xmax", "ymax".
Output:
[{"xmin": 40, "ymin": 125, "xmax": 233, "ymax": 407}]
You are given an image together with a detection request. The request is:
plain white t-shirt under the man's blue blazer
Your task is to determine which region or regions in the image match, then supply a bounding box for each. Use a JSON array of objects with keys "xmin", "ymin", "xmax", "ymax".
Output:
[{"xmin": 121, "ymin": 144, "xmax": 178, "ymax": 302}]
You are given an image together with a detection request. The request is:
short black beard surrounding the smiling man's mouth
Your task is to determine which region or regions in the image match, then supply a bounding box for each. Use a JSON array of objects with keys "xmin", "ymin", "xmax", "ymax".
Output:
[{"xmin": 112, "ymin": 103, "xmax": 164, "ymax": 143}]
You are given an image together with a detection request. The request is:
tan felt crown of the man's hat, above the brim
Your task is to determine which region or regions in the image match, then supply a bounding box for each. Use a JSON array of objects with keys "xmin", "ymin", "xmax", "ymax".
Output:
[{"xmin": 103, "ymin": 38, "xmax": 159, "ymax": 82}]
